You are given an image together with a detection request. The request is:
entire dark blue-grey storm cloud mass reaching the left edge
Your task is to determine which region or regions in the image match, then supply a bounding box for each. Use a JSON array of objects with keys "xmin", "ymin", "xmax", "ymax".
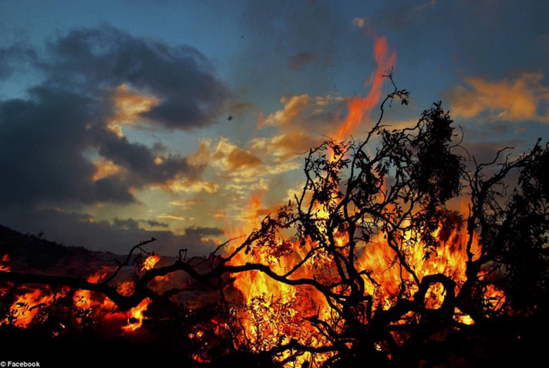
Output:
[{"xmin": 0, "ymin": 27, "xmax": 227, "ymax": 208}]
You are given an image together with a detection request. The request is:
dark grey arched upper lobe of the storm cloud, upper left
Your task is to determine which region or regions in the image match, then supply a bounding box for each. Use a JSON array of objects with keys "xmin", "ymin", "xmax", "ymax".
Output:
[{"xmin": 41, "ymin": 27, "xmax": 228, "ymax": 130}]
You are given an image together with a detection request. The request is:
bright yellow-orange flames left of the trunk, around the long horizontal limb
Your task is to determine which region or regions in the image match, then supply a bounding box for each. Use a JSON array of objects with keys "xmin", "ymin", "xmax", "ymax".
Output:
[{"xmin": 224, "ymin": 194, "xmax": 330, "ymax": 363}]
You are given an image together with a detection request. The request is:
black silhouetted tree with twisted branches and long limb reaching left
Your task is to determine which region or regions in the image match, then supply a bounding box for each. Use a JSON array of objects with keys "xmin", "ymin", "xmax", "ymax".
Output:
[{"xmin": 0, "ymin": 76, "xmax": 549, "ymax": 367}]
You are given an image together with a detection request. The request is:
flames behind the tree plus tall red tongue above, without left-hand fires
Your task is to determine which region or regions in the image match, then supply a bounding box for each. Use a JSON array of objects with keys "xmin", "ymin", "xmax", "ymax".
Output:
[{"xmin": 216, "ymin": 37, "xmax": 505, "ymax": 366}]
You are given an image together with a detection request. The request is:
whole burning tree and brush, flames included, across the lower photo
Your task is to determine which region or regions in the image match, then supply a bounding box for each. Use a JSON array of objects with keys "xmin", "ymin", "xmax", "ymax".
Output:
[{"xmin": 0, "ymin": 80, "xmax": 549, "ymax": 367}]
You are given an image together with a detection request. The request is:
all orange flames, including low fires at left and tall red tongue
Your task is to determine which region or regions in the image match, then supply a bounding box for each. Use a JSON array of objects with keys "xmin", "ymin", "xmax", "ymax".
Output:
[{"xmin": 0, "ymin": 32, "xmax": 524, "ymax": 367}]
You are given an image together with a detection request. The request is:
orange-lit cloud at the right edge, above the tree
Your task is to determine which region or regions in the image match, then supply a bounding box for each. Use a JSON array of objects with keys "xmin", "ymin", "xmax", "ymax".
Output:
[{"xmin": 448, "ymin": 73, "xmax": 549, "ymax": 123}]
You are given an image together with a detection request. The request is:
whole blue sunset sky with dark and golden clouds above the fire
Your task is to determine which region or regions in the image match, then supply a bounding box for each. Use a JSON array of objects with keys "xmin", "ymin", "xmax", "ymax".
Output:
[{"xmin": 0, "ymin": 0, "xmax": 549, "ymax": 255}]
